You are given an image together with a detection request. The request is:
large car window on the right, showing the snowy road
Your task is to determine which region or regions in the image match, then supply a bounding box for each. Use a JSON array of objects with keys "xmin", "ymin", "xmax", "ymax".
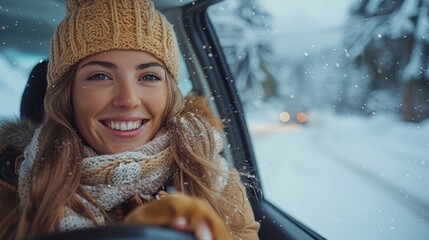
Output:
[{"xmin": 209, "ymin": 0, "xmax": 429, "ymax": 239}]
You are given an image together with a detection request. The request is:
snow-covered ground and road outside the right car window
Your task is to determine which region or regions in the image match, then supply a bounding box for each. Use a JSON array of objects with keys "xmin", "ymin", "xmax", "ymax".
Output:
[{"xmin": 247, "ymin": 111, "xmax": 429, "ymax": 239}]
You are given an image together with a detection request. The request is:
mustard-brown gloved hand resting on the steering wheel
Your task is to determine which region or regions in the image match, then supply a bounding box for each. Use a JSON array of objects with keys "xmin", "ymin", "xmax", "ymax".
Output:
[{"xmin": 124, "ymin": 194, "xmax": 232, "ymax": 240}]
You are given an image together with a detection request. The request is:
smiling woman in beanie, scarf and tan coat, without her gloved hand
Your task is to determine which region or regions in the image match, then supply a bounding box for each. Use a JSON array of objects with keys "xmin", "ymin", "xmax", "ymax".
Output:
[{"xmin": 0, "ymin": 0, "xmax": 259, "ymax": 239}]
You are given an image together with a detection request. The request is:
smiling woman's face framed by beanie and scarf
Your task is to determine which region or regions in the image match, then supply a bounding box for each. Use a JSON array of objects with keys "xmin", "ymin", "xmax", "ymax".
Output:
[{"xmin": 72, "ymin": 50, "xmax": 168, "ymax": 154}]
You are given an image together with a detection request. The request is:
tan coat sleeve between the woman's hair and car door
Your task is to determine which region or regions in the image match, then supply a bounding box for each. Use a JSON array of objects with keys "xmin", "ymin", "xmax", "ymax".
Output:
[{"xmin": 222, "ymin": 169, "xmax": 260, "ymax": 240}]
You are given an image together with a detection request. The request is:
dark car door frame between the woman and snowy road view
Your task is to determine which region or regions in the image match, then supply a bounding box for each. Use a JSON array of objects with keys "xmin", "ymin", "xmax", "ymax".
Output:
[{"xmin": 167, "ymin": 0, "xmax": 324, "ymax": 239}]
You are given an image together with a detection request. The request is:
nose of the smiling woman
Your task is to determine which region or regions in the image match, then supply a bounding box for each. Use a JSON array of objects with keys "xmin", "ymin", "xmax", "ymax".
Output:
[{"xmin": 113, "ymin": 81, "xmax": 140, "ymax": 108}]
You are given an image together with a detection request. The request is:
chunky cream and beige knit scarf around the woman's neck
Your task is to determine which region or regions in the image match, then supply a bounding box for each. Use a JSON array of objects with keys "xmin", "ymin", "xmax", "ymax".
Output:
[{"xmin": 19, "ymin": 128, "xmax": 171, "ymax": 231}]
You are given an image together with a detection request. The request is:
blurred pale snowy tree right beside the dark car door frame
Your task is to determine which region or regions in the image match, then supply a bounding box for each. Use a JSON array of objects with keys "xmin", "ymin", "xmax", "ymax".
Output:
[{"xmin": 211, "ymin": 0, "xmax": 279, "ymax": 104}]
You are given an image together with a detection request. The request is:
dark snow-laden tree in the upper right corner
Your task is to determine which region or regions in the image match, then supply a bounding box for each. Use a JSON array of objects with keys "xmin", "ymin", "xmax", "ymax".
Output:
[{"xmin": 347, "ymin": 0, "xmax": 429, "ymax": 122}]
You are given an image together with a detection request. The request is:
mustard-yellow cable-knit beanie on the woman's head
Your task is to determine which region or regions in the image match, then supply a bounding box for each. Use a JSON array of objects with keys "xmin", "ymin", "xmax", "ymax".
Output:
[{"xmin": 48, "ymin": 0, "xmax": 179, "ymax": 86}]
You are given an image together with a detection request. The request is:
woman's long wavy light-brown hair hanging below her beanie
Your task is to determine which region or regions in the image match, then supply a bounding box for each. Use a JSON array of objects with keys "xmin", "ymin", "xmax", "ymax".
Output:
[{"xmin": 0, "ymin": 57, "xmax": 241, "ymax": 239}]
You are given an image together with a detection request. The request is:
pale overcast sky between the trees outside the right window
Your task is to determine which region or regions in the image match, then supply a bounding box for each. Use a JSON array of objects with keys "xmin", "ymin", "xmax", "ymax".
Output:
[{"xmin": 261, "ymin": 0, "xmax": 356, "ymax": 56}]
